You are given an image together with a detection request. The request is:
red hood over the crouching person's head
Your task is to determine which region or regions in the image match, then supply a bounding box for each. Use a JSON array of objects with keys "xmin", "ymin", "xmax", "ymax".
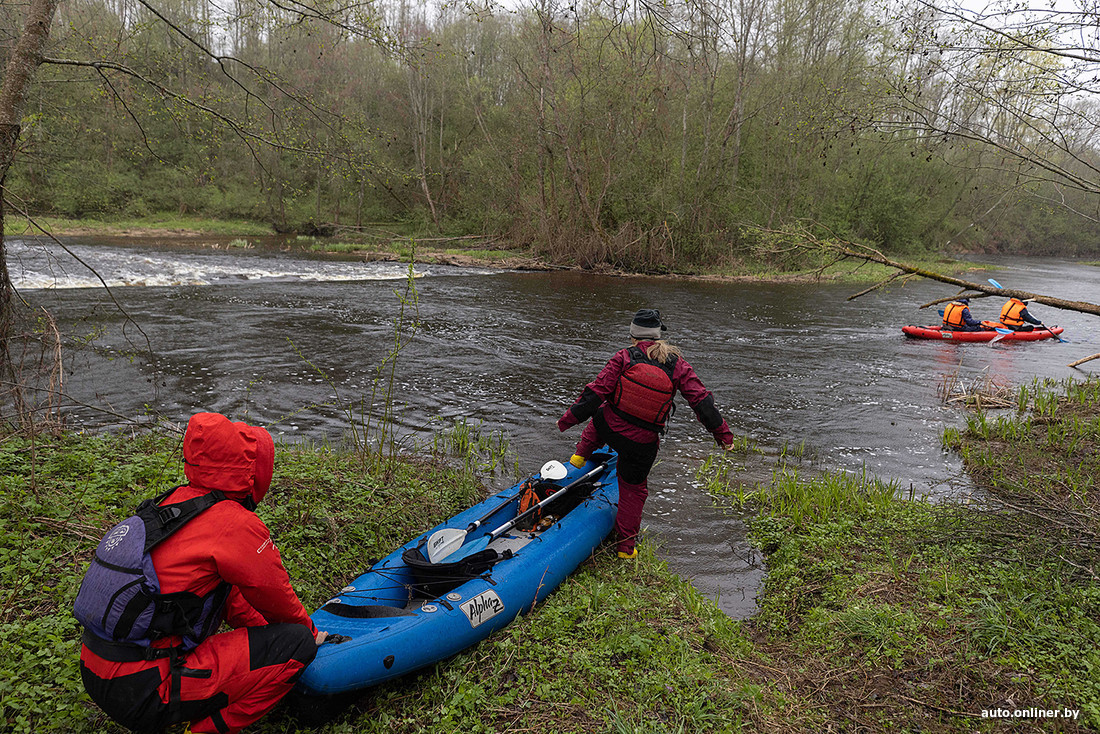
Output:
[{"xmin": 184, "ymin": 413, "xmax": 275, "ymax": 503}]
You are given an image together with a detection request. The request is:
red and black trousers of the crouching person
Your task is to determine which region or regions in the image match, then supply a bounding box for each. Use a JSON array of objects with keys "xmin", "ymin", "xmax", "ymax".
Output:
[{"xmin": 80, "ymin": 624, "xmax": 317, "ymax": 734}]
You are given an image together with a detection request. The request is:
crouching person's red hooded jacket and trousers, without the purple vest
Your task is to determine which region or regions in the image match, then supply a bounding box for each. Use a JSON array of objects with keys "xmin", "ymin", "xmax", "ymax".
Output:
[{"xmin": 80, "ymin": 413, "xmax": 326, "ymax": 734}]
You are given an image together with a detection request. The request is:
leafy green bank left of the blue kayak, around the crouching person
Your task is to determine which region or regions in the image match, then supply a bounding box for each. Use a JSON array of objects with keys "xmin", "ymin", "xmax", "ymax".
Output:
[{"xmin": 0, "ymin": 426, "xmax": 484, "ymax": 732}]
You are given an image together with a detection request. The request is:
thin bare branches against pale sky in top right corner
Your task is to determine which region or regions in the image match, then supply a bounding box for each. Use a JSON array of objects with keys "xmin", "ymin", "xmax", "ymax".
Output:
[{"xmin": 873, "ymin": 0, "xmax": 1100, "ymax": 221}]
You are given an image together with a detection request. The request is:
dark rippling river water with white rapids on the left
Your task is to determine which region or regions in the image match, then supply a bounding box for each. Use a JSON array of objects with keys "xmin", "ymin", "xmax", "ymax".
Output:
[{"xmin": 9, "ymin": 240, "xmax": 1100, "ymax": 617}]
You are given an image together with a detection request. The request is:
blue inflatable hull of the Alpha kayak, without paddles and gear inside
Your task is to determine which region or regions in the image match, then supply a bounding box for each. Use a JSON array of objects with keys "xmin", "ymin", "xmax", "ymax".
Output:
[{"xmin": 298, "ymin": 453, "xmax": 618, "ymax": 695}]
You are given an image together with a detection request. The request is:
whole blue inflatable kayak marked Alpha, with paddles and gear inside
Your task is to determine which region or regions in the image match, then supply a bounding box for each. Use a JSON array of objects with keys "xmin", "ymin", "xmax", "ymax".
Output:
[{"xmin": 298, "ymin": 453, "xmax": 618, "ymax": 695}]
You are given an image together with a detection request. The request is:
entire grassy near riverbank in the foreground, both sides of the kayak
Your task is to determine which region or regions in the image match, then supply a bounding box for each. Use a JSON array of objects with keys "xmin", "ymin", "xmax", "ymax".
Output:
[{"xmin": 0, "ymin": 381, "xmax": 1100, "ymax": 734}]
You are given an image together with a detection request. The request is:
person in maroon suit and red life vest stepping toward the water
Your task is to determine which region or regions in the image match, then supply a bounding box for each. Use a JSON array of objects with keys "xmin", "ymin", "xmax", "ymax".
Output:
[{"xmin": 558, "ymin": 308, "xmax": 734, "ymax": 558}]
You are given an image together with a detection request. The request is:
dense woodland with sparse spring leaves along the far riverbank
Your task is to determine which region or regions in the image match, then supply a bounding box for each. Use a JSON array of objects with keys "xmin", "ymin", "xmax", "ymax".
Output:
[{"xmin": 4, "ymin": 0, "xmax": 1100, "ymax": 269}]
